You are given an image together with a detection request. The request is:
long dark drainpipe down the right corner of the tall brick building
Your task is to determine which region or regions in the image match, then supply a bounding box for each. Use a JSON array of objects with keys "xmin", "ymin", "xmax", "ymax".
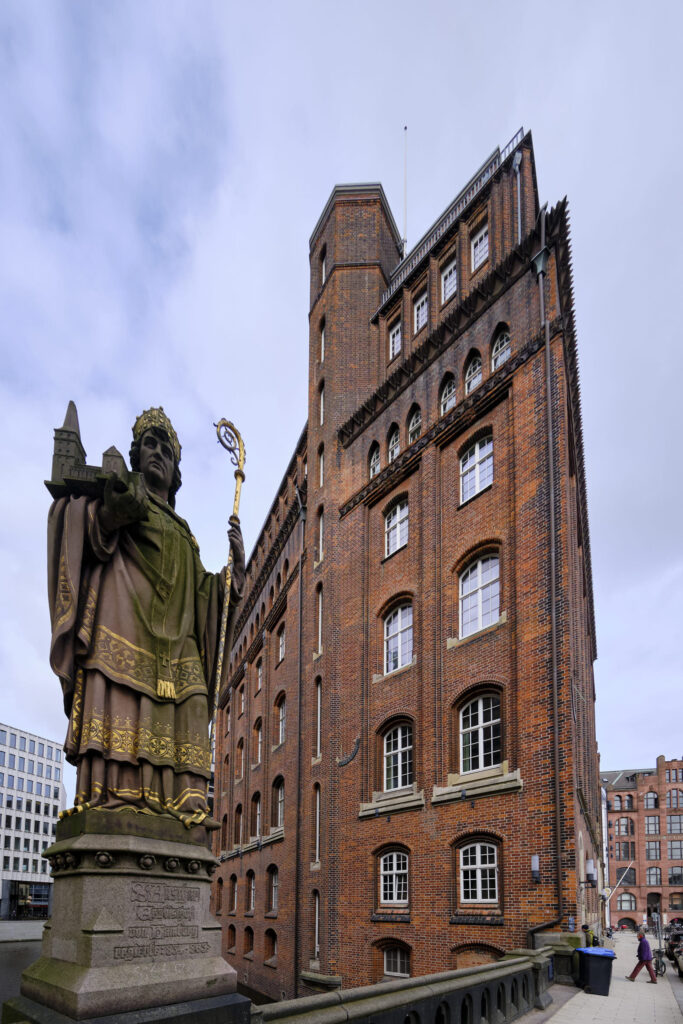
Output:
[{"xmin": 518, "ymin": 203, "xmax": 564, "ymax": 938}]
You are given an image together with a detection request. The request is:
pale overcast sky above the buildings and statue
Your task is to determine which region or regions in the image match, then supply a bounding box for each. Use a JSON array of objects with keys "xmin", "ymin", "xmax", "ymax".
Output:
[{"xmin": 0, "ymin": 0, "xmax": 683, "ymax": 800}]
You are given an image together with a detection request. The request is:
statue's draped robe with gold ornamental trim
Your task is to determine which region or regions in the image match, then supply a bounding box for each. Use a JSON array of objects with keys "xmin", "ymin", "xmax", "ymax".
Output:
[{"xmin": 48, "ymin": 494, "xmax": 232, "ymax": 827}]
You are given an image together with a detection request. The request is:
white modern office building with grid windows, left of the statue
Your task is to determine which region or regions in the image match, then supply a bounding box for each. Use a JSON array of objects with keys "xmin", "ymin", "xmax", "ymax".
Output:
[{"xmin": 0, "ymin": 723, "xmax": 67, "ymax": 919}]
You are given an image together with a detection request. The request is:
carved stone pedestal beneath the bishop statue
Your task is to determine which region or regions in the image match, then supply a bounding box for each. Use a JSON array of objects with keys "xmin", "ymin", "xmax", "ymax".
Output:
[{"xmin": 22, "ymin": 810, "xmax": 237, "ymax": 1020}]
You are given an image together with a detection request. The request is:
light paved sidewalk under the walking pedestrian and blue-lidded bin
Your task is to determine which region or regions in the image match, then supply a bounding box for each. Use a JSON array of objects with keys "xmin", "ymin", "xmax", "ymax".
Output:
[{"xmin": 540, "ymin": 932, "xmax": 683, "ymax": 1024}]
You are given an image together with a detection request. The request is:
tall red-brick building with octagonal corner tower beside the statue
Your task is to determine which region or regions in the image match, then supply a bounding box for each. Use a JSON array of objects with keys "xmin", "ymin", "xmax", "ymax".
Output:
[{"xmin": 214, "ymin": 132, "xmax": 601, "ymax": 997}]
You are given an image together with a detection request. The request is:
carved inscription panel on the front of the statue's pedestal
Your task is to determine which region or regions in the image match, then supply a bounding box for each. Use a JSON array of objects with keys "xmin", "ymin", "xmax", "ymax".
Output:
[{"xmin": 114, "ymin": 882, "xmax": 211, "ymax": 961}]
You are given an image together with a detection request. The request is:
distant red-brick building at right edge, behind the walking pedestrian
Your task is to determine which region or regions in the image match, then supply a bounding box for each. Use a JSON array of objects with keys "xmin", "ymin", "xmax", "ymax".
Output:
[{"xmin": 602, "ymin": 755, "xmax": 683, "ymax": 928}]
